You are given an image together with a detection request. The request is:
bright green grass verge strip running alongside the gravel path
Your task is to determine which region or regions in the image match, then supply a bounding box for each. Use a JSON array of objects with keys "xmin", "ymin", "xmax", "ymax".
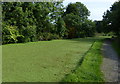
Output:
[{"xmin": 62, "ymin": 40, "xmax": 104, "ymax": 82}]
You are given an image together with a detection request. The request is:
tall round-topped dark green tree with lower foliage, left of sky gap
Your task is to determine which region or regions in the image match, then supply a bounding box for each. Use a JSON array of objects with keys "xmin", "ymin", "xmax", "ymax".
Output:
[{"xmin": 64, "ymin": 2, "xmax": 95, "ymax": 38}]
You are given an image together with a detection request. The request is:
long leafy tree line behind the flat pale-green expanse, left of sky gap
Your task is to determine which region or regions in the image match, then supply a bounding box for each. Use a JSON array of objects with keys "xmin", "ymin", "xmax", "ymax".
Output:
[{"xmin": 2, "ymin": 2, "xmax": 95, "ymax": 44}]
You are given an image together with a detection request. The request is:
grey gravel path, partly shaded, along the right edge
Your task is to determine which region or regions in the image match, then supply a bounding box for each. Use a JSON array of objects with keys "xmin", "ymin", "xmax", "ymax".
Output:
[{"xmin": 101, "ymin": 40, "xmax": 120, "ymax": 82}]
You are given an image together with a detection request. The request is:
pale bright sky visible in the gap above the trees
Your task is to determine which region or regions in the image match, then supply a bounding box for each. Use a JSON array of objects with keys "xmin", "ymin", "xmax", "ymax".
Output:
[{"xmin": 63, "ymin": 0, "xmax": 117, "ymax": 20}]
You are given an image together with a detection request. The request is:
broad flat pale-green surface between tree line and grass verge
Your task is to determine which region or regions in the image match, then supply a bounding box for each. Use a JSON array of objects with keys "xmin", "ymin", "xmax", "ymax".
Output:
[{"xmin": 2, "ymin": 38, "xmax": 96, "ymax": 82}]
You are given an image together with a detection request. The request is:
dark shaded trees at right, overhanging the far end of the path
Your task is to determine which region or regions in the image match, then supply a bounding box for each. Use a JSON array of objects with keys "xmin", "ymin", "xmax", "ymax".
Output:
[{"xmin": 97, "ymin": 1, "xmax": 120, "ymax": 37}]
